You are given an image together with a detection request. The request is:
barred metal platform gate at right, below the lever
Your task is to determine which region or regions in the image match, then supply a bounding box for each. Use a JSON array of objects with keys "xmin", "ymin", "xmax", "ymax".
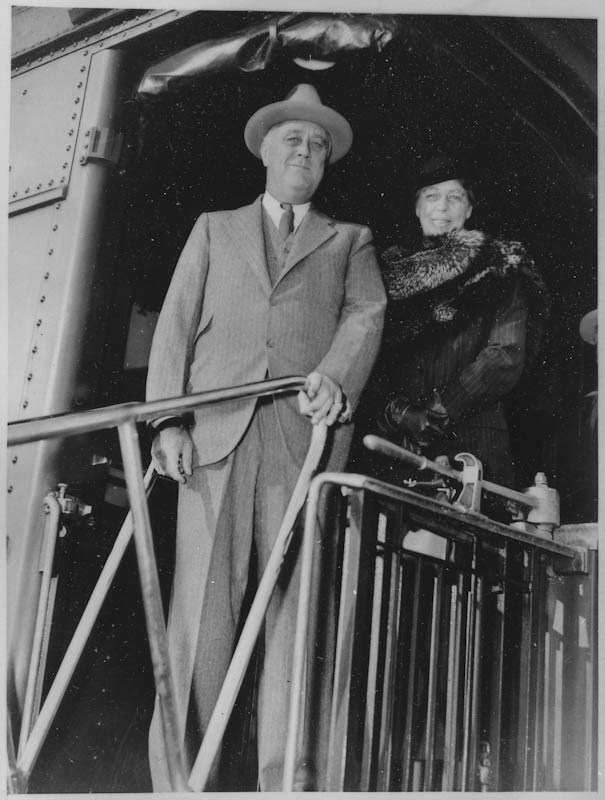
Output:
[{"xmin": 283, "ymin": 473, "xmax": 590, "ymax": 792}]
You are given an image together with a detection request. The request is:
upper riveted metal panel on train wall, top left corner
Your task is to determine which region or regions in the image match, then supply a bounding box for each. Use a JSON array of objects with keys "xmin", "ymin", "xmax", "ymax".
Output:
[{"xmin": 9, "ymin": 52, "xmax": 90, "ymax": 213}]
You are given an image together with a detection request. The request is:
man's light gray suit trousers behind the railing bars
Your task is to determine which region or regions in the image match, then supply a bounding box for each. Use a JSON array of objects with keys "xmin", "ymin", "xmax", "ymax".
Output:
[{"xmin": 150, "ymin": 398, "xmax": 332, "ymax": 791}]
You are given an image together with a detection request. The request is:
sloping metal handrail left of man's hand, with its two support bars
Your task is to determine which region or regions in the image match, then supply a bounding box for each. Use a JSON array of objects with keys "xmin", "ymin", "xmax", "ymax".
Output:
[{"xmin": 7, "ymin": 376, "xmax": 305, "ymax": 791}]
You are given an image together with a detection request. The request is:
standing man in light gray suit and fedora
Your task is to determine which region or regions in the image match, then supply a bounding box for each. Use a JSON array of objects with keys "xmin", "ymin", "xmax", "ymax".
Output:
[{"xmin": 148, "ymin": 84, "xmax": 386, "ymax": 790}]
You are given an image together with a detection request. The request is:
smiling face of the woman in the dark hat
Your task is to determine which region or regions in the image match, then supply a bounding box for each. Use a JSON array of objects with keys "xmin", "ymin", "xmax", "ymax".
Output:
[{"xmin": 416, "ymin": 180, "xmax": 473, "ymax": 236}]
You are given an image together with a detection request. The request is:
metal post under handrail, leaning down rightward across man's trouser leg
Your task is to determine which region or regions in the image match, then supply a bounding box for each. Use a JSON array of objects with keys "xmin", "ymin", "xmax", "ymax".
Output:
[{"xmin": 118, "ymin": 420, "xmax": 187, "ymax": 791}]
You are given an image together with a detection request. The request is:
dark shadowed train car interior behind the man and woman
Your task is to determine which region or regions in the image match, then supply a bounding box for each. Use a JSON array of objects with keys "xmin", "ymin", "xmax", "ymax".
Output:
[{"xmin": 24, "ymin": 12, "xmax": 597, "ymax": 792}]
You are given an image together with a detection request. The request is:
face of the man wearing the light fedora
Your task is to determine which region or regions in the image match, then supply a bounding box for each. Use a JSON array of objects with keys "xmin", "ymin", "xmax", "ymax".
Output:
[{"xmin": 260, "ymin": 120, "xmax": 330, "ymax": 203}]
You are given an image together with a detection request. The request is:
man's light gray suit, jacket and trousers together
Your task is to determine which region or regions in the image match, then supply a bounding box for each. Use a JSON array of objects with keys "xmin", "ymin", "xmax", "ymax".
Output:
[{"xmin": 147, "ymin": 198, "xmax": 385, "ymax": 790}]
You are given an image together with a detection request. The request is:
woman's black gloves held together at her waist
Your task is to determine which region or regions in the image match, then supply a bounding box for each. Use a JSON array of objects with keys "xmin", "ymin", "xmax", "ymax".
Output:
[{"xmin": 378, "ymin": 395, "xmax": 448, "ymax": 447}]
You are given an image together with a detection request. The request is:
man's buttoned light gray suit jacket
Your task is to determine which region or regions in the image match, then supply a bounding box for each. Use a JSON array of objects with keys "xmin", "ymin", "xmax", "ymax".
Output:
[{"xmin": 147, "ymin": 197, "xmax": 386, "ymax": 466}]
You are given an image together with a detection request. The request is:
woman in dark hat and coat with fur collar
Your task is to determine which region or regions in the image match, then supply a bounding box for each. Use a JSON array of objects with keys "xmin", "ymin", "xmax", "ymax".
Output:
[{"xmin": 373, "ymin": 156, "xmax": 546, "ymax": 486}]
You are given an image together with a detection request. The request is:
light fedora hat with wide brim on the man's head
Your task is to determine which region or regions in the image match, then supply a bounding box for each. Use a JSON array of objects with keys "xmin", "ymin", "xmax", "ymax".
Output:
[{"xmin": 244, "ymin": 83, "xmax": 353, "ymax": 164}]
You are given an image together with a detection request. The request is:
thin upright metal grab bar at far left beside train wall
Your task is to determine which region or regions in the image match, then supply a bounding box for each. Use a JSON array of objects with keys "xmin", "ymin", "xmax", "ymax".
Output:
[{"xmin": 17, "ymin": 494, "xmax": 61, "ymax": 759}]
